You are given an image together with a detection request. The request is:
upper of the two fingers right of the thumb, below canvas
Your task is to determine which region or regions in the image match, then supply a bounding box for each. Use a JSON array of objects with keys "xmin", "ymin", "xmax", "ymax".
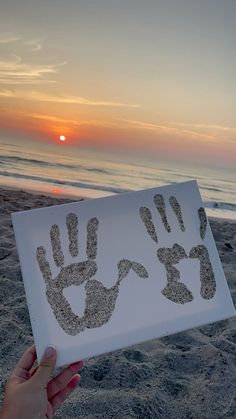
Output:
[{"xmin": 47, "ymin": 361, "xmax": 83, "ymax": 399}]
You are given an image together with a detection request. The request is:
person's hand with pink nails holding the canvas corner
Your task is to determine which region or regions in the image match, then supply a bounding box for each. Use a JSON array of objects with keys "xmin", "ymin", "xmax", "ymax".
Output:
[{"xmin": 0, "ymin": 345, "xmax": 83, "ymax": 419}]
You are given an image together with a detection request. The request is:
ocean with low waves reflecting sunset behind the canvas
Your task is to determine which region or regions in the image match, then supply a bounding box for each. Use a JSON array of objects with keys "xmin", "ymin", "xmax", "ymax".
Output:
[{"xmin": 0, "ymin": 139, "xmax": 236, "ymax": 220}]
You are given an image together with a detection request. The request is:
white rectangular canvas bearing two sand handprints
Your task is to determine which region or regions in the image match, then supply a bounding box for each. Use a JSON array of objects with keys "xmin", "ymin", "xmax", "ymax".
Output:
[{"xmin": 12, "ymin": 181, "xmax": 235, "ymax": 366}]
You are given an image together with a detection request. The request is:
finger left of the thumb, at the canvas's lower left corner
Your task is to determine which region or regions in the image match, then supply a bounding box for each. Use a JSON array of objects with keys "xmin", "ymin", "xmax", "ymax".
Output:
[{"xmin": 11, "ymin": 345, "xmax": 36, "ymax": 382}]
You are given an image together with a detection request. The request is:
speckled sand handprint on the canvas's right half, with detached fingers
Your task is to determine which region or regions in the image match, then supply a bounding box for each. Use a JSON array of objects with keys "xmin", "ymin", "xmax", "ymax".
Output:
[{"xmin": 139, "ymin": 194, "xmax": 216, "ymax": 304}]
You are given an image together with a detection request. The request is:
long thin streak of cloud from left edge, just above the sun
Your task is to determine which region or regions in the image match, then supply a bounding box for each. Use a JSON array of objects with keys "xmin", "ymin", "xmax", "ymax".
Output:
[{"xmin": 0, "ymin": 89, "xmax": 140, "ymax": 108}]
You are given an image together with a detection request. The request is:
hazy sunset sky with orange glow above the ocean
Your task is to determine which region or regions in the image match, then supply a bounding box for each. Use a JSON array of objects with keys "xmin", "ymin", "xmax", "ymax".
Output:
[{"xmin": 0, "ymin": 0, "xmax": 236, "ymax": 168}]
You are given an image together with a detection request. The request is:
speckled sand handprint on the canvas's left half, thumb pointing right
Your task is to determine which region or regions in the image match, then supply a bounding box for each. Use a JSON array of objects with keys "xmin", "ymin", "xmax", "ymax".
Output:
[{"xmin": 36, "ymin": 213, "xmax": 148, "ymax": 335}]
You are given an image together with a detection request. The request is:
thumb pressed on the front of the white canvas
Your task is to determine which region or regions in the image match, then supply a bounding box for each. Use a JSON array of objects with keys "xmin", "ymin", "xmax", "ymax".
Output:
[{"xmin": 32, "ymin": 346, "xmax": 57, "ymax": 387}]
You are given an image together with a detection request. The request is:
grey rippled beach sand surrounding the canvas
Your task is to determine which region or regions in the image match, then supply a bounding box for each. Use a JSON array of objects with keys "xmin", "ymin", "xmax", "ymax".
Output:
[{"xmin": 0, "ymin": 189, "xmax": 236, "ymax": 419}]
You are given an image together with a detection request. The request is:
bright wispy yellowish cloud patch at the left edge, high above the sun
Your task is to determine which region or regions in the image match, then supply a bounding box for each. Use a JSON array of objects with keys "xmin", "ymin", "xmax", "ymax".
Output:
[{"xmin": 0, "ymin": 54, "xmax": 66, "ymax": 85}]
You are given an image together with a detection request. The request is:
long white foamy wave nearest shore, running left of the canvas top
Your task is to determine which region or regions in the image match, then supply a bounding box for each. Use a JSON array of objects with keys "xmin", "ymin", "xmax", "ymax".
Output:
[{"xmin": 0, "ymin": 171, "xmax": 130, "ymax": 193}]
